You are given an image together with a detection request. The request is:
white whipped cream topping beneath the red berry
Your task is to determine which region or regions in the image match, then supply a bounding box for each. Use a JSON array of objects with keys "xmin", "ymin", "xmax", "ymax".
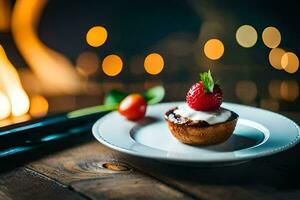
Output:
[{"xmin": 174, "ymin": 103, "xmax": 231, "ymax": 124}]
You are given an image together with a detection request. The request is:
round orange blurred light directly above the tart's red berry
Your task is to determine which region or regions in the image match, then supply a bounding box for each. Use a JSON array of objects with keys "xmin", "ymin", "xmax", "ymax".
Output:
[{"xmin": 204, "ymin": 39, "xmax": 224, "ymax": 60}]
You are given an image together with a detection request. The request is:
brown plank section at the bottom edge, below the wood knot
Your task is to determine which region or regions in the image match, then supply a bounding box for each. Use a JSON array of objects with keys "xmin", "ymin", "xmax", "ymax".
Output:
[{"xmin": 71, "ymin": 174, "xmax": 190, "ymax": 200}]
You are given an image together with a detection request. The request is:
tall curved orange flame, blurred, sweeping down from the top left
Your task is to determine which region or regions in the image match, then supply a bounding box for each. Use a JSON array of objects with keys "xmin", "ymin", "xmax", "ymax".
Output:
[{"xmin": 11, "ymin": 0, "xmax": 81, "ymax": 93}]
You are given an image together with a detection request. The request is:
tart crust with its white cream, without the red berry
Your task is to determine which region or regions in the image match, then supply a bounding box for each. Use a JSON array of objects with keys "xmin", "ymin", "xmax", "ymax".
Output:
[{"xmin": 165, "ymin": 104, "xmax": 238, "ymax": 145}]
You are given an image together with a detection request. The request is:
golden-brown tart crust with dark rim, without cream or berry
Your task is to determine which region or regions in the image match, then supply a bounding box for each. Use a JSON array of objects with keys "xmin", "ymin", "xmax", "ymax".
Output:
[{"xmin": 165, "ymin": 108, "xmax": 238, "ymax": 145}]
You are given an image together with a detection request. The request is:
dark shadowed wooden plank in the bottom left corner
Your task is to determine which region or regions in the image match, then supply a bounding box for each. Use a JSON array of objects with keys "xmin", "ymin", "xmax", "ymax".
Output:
[{"xmin": 0, "ymin": 168, "xmax": 86, "ymax": 200}]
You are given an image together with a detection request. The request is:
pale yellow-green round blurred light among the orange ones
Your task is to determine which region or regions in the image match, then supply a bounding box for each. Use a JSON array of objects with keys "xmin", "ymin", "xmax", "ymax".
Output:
[{"xmin": 235, "ymin": 25, "xmax": 257, "ymax": 48}]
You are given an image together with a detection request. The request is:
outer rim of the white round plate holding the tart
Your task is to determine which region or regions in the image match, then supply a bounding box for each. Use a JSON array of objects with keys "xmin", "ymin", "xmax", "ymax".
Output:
[{"xmin": 92, "ymin": 101, "xmax": 300, "ymax": 163}]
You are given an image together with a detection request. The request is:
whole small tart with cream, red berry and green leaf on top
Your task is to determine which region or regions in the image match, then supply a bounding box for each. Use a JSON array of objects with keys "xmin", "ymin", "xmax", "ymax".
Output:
[{"xmin": 165, "ymin": 71, "xmax": 238, "ymax": 145}]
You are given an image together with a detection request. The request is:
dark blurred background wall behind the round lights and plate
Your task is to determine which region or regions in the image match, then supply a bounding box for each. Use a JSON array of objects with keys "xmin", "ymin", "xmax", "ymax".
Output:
[{"xmin": 0, "ymin": 0, "xmax": 300, "ymax": 119}]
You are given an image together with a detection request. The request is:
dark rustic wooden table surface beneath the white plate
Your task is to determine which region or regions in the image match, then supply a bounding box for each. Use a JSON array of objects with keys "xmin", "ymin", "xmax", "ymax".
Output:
[{"xmin": 0, "ymin": 113, "xmax": 300, "ymax": 200}]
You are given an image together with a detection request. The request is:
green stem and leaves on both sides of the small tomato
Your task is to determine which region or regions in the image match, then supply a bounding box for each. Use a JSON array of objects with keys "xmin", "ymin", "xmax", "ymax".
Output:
[{"xmin": 67, "ymin": 86, "xmax": 165, "ymax": 118}]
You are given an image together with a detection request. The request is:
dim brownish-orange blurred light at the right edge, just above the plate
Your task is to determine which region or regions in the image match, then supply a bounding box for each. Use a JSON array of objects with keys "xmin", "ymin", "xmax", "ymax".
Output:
[{"xmin": 280, "ymin": 80, "xmax": 299, "ymax": 101}]
